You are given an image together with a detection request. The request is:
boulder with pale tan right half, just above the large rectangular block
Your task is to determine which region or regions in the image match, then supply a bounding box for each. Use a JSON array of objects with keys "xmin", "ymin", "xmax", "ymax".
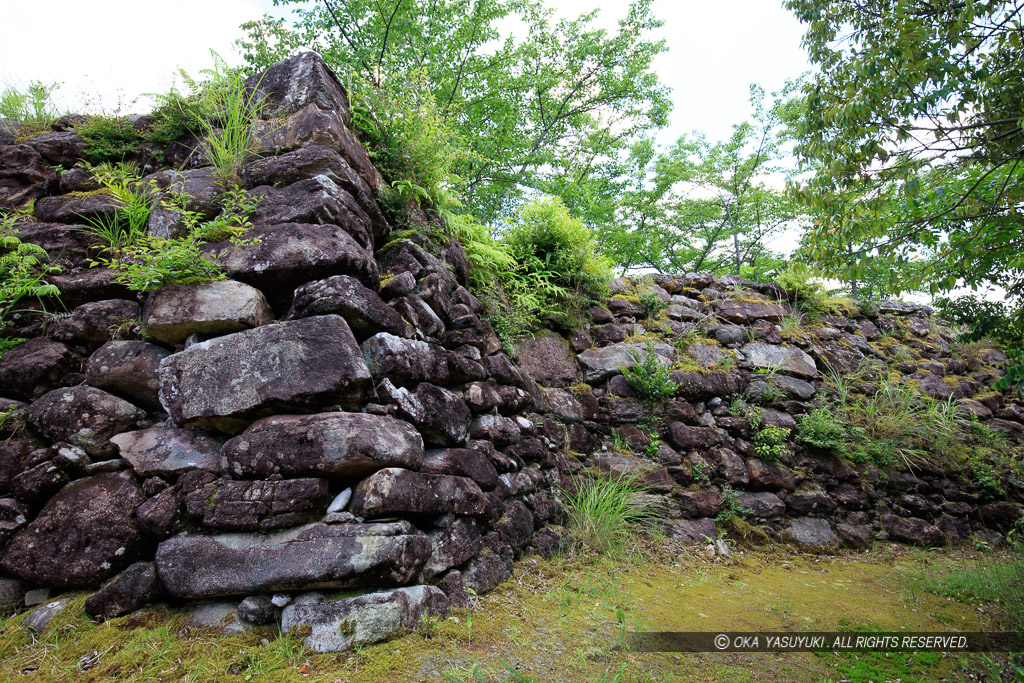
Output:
[{"xmin": 142, "ymin": 280, "xmax": 273, "ymax": 346}]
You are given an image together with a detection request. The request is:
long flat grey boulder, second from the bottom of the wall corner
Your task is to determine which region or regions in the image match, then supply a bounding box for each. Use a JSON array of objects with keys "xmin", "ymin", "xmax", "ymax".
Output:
[{"xmin": 157, "ymin": 522, "xmax": 430, "ymax": 598}]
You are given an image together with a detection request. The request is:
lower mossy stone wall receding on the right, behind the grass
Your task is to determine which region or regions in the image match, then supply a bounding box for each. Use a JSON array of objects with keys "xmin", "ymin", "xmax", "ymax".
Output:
[{"xmin": 519, "ymin": 273, "xmax": 1024, "ymax": 551}]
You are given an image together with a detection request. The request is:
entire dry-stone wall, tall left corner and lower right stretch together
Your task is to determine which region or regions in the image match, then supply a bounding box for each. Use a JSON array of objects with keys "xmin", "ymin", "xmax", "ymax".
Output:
[{"xmin": 0, "ymin": 54, "xmax": 1024, "ymax": 650}]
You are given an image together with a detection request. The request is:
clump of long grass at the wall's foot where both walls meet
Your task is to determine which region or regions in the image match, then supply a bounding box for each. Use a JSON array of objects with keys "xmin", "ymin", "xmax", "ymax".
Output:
[{"xmin": 561, "ymin": 474, "xmax": 664, "ymax": 554}]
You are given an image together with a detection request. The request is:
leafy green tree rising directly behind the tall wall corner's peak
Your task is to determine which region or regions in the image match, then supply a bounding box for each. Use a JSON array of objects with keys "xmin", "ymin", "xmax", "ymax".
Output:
[{"xmin": 240, "ymin": 0, "xmax": 670, "ymax": 223}]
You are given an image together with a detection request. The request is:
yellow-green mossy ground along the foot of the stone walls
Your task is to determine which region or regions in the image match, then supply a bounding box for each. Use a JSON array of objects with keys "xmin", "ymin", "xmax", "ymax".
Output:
[{"xmin": 0, "ymin": 541, "xmax": 1008, "ymax": 683}]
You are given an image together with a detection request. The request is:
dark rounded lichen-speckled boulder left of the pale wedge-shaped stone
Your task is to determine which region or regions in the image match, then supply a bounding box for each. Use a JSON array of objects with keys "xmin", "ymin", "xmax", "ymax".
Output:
[{"xmin": 28, "ymin": 386, "xmax": 145, "ymax": 458}]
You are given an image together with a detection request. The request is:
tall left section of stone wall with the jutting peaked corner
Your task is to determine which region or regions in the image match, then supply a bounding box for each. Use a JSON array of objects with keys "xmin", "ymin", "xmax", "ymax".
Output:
[{"xmin": 0, "ymin": 54, "xmax": 561, "ymax": 648}]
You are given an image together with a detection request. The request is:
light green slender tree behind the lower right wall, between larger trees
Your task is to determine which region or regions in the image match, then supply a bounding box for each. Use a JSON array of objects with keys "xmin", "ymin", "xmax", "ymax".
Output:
[{"xmin": 589, "ymin": 86, "xmax": 801, "ymax": 278}]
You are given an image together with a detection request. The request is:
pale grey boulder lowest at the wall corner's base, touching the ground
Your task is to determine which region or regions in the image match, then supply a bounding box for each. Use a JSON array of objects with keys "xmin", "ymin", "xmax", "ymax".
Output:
[{"xmin": 281, "ymin": 586, "xmax": 449, "ymax": 652}]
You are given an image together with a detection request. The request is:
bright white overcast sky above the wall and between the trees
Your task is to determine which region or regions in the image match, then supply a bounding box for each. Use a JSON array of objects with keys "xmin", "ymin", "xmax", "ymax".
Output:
[{"xmin": 0, "ymin": 0, "xmax": 809, "ymax": 143}]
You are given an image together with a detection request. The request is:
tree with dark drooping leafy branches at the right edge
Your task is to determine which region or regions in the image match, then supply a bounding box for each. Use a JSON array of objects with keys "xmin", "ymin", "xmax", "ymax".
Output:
[{"xmin": 785, "ymin": 0, "xmax": 1024, "ymax": 292}]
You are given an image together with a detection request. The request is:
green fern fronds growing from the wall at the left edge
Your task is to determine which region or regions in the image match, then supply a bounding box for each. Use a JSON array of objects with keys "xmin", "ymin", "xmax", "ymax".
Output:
[{"xmin": 0, "ymin": 214, "xmax": 60, "ymax": 330}]
